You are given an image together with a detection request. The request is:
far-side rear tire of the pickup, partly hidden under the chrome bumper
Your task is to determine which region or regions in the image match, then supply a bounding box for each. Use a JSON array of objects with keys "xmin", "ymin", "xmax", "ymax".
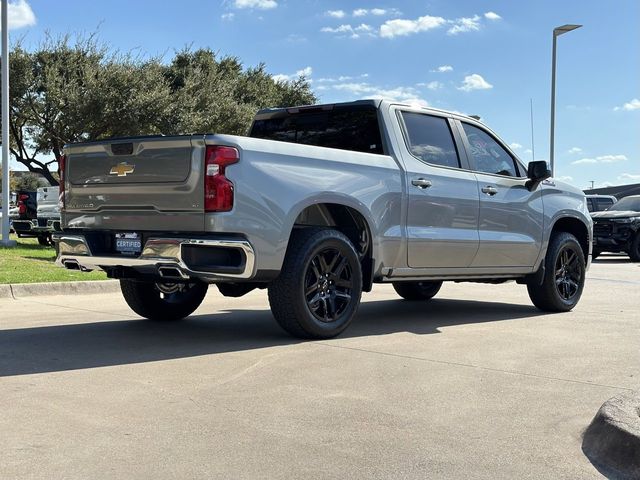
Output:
[{"xmin": 120, "ymin": 279, "xmax": 209, "ymax": 321}]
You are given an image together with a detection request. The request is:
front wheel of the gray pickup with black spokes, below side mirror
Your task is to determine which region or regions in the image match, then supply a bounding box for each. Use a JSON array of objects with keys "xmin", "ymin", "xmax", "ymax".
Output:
[{"xmin": 527, "ymin": 232, "xmax": 586, "ymax": 312}]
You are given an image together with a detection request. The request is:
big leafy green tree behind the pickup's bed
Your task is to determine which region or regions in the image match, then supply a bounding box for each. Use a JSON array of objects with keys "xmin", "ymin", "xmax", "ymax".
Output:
[{"xmin": 1, "ymin": 36, "xmax": 316, "ymax": 185}]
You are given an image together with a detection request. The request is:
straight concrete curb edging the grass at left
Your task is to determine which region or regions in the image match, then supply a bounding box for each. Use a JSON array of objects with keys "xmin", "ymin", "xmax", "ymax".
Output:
[{"xmin": 0, "ymin": 280, "xmax": 120, "ymax": 299}]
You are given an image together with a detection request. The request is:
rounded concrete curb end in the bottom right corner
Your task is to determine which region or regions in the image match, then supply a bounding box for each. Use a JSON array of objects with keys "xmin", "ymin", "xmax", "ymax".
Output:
[{"xmin": 582, "ymin": 392, "xmax": 640, "ymax": 480}]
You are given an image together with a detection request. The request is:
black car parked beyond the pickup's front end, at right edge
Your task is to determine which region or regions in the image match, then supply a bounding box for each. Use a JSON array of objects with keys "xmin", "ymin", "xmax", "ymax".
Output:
[{"xmin": 591, "ymin": 195, "xmax": 640, "ymax": 262}]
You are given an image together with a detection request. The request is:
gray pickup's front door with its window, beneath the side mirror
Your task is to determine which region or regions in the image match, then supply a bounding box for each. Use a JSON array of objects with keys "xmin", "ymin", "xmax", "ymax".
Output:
[{"xmin": 457, "ymin": 122, "xmax": 543, "ymax": 267}]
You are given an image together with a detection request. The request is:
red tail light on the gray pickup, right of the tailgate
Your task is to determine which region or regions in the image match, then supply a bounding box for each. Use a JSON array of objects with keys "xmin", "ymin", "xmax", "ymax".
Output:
[{"xmin": 204, "ymin": 145, "xmax": 240, "ymax": 212}]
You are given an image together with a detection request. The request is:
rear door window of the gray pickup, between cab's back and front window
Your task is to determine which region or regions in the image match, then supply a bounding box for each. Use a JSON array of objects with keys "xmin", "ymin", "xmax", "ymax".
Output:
[{"xmin": 402, "ymin": 112, "xmax": 460, "ymax": 168}]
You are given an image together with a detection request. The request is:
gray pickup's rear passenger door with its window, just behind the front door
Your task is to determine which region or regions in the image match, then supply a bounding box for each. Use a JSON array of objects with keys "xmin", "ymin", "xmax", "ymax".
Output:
[{"xmin": 398, "ymin": 111, "xmax": 479, "ymax": 268}]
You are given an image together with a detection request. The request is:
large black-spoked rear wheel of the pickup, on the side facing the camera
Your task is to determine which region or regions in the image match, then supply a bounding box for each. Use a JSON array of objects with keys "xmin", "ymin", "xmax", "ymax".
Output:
[{"xmin": 268, "ymin": 227, "xmax": 362, "ymax": 339}]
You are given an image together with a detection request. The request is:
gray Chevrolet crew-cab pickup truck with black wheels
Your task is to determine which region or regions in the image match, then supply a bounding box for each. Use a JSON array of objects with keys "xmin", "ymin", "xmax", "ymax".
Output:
[{"xmin": 54, "ymin": 100, "xmax": 593, "ymax": 338}]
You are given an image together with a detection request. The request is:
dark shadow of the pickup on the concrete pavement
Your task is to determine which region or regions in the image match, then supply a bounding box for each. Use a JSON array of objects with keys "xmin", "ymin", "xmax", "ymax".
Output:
[{"xmin": 0, "ymin": 299, "xmax": 542, "ymax": 377}]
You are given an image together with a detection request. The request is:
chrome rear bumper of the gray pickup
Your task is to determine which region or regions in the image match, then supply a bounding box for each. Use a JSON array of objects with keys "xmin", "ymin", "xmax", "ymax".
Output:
[{"xmin": 53, "ymin": 233, "xmax": 255, "ymax": 282}]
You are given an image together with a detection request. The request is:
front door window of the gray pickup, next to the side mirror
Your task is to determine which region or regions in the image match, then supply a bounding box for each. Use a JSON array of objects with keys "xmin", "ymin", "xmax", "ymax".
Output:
[{"xmin": 462, "ymin": 123, "xmax": 518, "ymax": 177}]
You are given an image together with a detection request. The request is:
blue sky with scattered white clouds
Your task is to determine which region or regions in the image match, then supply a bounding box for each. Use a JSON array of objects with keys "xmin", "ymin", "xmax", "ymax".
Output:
[{"xmin": 9, "ymin": 0, "xmax": 640, "ymax": 188}]
